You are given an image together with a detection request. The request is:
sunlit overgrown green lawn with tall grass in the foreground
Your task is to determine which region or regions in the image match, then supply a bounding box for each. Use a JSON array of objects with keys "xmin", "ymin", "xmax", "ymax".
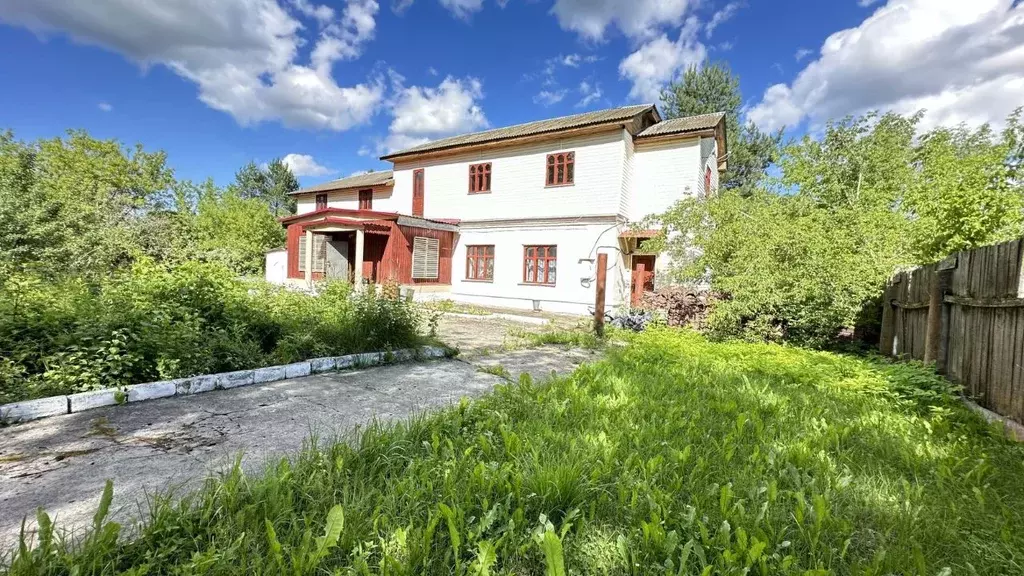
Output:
[{"xmin": 11, "ymin": 330, "xmax": 1024, "ymax": 575}]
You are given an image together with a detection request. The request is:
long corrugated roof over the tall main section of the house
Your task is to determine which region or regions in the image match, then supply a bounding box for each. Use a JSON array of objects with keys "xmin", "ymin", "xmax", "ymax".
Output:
[{"xmin": 381, "ymin": 104, "xmax": 656, "ymax": 160}]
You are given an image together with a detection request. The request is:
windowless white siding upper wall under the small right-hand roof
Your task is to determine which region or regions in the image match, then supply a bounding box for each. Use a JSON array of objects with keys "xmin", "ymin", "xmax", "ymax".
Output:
[{"xmin": 629, "ymin": 138, "xmax": 703, "ymax": 221}]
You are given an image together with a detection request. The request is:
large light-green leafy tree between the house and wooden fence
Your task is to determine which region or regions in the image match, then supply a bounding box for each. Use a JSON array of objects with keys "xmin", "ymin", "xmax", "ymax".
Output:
[{"xmin": 653, "ymin": 106, "xmax": 1024, "ymax": 344}]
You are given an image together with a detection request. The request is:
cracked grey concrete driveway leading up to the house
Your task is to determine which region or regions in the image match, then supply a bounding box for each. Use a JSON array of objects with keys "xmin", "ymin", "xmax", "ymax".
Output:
[{"xmin": 0, "ymin": 313, "xmax": 594, "ymax": 549}]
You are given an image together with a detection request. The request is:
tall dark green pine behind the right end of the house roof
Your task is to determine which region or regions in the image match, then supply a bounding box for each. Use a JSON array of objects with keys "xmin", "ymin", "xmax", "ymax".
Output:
[{"xmin": 662, "ymin": 63, "xmax": 782, "ymax": 195}]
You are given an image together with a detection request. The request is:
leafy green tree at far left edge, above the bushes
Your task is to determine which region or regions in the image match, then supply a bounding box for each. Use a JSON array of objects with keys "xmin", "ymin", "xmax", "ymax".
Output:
[{"xmin": 0, "ymin": 130, "xmax": 174, "ymax": 276}]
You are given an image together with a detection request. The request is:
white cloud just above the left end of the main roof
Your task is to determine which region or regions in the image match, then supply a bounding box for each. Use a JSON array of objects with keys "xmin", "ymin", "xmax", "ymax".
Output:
[{"xmin": 379, "ymin": 76, "xmax": 488, "ymax": 152}]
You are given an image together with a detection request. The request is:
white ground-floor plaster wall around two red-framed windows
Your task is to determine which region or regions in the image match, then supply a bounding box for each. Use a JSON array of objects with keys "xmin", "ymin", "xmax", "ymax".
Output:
[{"xmin": 450, "ymin": 222, "xmax": 630, "ymax": 315}]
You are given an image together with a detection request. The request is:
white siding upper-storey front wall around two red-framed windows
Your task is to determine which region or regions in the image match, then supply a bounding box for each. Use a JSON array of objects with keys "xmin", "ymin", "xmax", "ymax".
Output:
[{"xmin": 393, "ymin": 130, "xmax": 629, "ymax": 221}]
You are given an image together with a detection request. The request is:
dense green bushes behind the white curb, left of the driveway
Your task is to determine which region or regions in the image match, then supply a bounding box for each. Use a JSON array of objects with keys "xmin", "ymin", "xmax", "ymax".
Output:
[{"xmin": 0, "ymin": 261, "xmax": 420, "ymax": 403}]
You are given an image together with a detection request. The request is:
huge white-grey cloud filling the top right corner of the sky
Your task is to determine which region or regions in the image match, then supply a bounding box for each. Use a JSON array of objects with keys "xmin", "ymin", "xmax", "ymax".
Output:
[{"xmin": 748, "ymin": 0, "xmax": 1024, "ymax": 129}]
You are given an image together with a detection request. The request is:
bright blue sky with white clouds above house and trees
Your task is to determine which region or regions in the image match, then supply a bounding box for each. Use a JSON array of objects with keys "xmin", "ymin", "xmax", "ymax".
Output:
[{"xmin": 0, "ymin": 0, "xmax": 1024, "ymax": 184}]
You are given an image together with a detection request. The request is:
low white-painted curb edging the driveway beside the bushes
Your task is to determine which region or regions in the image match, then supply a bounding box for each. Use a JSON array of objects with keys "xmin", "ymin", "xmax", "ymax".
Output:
[{"xmin": 0, "ymin": 346, "xmax": 447, "ymax": 423}]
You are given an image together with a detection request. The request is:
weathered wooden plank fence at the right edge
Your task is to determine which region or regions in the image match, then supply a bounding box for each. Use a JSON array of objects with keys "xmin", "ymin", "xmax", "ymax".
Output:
[{"xmin": 879, "ymin": 239, "xmax": 1024, "ymax": 422}]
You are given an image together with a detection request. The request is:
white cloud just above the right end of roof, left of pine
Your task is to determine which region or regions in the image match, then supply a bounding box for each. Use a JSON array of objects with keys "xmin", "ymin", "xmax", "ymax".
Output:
[{"xmin": 618, "ymin": 16, "xmax": 708, "ymax": 102}]
